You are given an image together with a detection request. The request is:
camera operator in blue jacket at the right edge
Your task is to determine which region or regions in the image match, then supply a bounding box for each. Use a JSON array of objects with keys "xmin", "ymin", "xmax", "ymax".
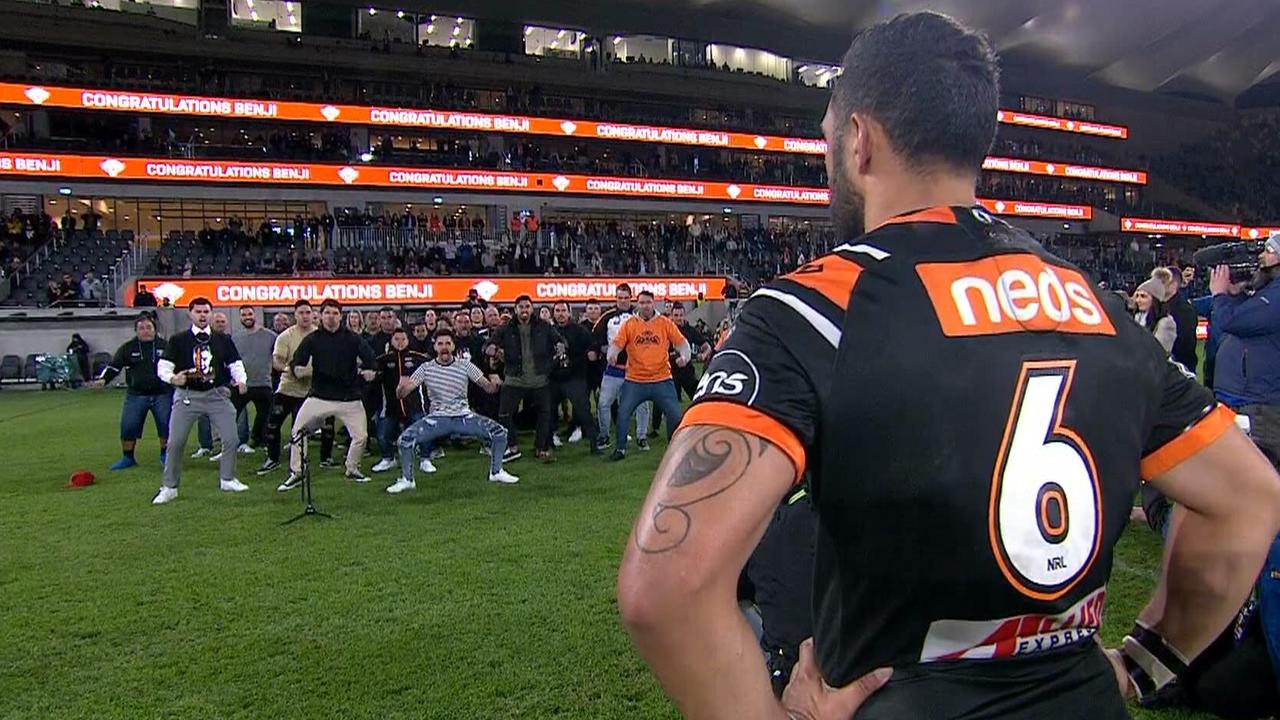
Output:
[{"xmin": 1210, "ymin": 236, "xmax": 1280, "ymax": 464}]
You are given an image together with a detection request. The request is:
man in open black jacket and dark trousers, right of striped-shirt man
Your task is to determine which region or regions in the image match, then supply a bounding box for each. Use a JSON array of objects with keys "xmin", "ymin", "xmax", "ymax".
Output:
[{"xmin": 493, "ymin": 295, "xmax": 563, "ymax": 461}]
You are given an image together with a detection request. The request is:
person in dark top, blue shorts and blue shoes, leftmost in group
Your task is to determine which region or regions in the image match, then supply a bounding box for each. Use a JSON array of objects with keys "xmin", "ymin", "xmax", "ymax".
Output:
[{"xmin": 95, "ymin": 313, "xmax": 173, "ymax": 470}]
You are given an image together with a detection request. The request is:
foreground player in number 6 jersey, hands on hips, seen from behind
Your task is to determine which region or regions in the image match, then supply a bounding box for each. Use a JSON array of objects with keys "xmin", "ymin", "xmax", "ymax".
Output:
[{"xmin": 618, "ymin": 13, "xmax": 1280, "ymax": 720}]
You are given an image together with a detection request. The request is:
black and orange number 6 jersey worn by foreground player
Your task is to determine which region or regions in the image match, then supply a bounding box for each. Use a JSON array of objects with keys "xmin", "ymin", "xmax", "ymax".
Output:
[{"xmin": 684, "ymin": 208, "xmax": 1231, "ymax": 717}]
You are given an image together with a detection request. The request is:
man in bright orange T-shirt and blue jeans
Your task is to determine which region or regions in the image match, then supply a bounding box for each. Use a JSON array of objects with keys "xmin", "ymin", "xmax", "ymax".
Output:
[{"xmin": 609, "ymin": 291, "xmax": 691, "ymax": 461}]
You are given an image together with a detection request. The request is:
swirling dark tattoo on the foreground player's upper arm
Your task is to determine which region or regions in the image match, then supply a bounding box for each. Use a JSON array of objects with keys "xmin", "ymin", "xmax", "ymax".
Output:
[{"xmin": 635, "ymin": 427, "xmax": 772, "ymax": 555}]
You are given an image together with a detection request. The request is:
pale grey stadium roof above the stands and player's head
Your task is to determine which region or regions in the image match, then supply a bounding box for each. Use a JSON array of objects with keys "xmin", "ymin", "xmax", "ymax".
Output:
[{"xmin": 422, "ymin": 0, "xmax": 1280, "ymax": 102}]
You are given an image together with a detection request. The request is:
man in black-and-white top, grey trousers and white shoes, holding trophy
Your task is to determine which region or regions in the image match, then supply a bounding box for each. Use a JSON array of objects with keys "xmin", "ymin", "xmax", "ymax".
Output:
[{"xmin": 151, "ymin": 297, "xmax": 248, "ymax": 505}]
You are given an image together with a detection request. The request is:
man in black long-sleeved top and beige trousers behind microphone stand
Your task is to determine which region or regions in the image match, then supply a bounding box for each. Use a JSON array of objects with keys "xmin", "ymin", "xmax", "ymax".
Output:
[{"xmin": 279, "ymin": 299, "xmax": 381, "ymax": 481}]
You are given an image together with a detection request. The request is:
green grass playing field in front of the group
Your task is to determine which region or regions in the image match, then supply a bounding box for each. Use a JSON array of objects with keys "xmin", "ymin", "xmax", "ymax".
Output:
[{"xmin": 0, "ymin": 391, "xmax": 1208, "ymax": 720}]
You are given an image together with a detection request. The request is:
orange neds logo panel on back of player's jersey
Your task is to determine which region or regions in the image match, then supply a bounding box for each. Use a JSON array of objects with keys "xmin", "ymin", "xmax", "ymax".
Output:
[{"xmin": 915, "ymin": 254, "xmax": 1116, "ymax": 337}]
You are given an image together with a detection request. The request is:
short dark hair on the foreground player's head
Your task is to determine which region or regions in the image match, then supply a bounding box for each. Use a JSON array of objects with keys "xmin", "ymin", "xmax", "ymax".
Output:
[{"xmin": 831, "ymin": 12, "xmax": 1000, "ymax": 173}]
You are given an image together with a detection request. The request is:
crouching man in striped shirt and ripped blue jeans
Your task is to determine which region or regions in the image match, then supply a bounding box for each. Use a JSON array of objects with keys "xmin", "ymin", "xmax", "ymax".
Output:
[{"xmin": 387, "ymin": 328, "xmax": 520, "ymax": 495}]
